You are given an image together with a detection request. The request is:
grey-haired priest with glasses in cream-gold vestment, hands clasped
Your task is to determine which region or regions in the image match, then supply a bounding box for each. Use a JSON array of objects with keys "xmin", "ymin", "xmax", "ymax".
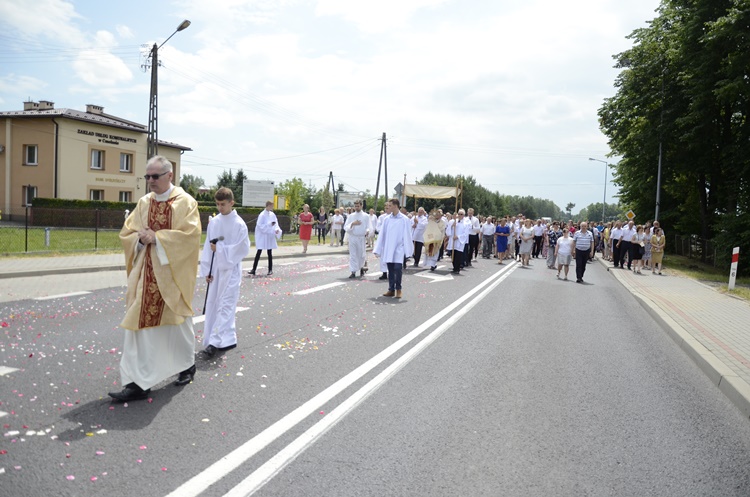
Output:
[{"xmin": 109, "ymin": 156, "xmax": 201, "ymax": 401}]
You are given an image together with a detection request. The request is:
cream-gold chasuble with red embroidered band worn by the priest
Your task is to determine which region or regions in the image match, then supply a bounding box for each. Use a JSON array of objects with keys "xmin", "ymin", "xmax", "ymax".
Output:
[{"xmin": 120, "ymin": 187, "xmax": 201, "ymax": 330}]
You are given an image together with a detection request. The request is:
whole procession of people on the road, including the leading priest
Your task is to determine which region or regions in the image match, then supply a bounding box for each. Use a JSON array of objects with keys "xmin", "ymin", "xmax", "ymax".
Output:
[{"xmin": 109, "ymin": 156, "xmax": 665, "ymax": 402}]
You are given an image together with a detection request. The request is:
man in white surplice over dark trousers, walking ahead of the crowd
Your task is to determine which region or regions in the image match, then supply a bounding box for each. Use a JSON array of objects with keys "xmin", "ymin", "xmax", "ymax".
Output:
[{"xmin": 373, "ymin": 198, "xmax": 414, "ymax": 298}]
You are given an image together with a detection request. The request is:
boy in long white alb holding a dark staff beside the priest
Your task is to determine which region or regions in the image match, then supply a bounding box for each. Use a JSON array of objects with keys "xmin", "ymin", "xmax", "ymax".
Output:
[{"xmin": 200, "ymin": 187, "xmax": 250, "ymax": 359}]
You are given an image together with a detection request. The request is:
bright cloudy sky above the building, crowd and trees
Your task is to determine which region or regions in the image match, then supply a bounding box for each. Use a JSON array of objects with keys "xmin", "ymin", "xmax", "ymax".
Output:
[{"xmin": 0, "ymin": 0, "xmax": 659, "ymax": 212}]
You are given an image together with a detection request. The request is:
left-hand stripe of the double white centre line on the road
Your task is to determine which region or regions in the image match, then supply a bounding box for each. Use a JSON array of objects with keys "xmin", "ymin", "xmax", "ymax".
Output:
[{"xmin": 166, "ymin": 264, "xmax": 515, "ymax": 497}]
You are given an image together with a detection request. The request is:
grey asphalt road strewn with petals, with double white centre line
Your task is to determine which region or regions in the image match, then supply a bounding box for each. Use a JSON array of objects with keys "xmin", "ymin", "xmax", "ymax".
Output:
[{"xmin": 0, "ymin": 256, "xmax": 750, "ymax": 497}]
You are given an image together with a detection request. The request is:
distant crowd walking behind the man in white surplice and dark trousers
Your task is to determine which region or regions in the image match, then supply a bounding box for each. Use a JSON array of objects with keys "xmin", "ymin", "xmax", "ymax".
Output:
[{"xmin": 322, "ymin": 205, "xmax": 666, "ymax": 283}]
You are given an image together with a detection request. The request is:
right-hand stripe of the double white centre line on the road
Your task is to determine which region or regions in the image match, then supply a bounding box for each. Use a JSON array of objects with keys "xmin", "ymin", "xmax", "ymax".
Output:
[{"xmin": 224, "ymin": 262, "xmax": 512, "ymax": 497}]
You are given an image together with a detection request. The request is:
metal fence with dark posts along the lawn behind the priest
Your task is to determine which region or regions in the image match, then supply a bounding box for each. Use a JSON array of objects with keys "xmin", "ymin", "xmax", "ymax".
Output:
[{"xmin": 0, "ymin": 207, "xmax": 291, "ymax": 255}]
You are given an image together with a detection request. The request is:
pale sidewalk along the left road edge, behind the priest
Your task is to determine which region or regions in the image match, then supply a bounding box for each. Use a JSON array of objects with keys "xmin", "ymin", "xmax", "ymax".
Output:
[{"xmin": 0, "ymin": 243, "xmax": 352, "ymax": 279}]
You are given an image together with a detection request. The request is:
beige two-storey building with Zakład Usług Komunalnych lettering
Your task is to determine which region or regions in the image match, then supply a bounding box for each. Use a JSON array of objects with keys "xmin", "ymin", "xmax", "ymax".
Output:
[{"xmin": 0, "ymin": 100, "xmax": 191, "ymax": 219}]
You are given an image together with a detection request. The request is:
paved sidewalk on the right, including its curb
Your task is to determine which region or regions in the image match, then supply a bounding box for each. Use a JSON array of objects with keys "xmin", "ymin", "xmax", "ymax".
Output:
[{"xmin": 599, "ymin": 259, "xmax": 750, "ymax": 417}]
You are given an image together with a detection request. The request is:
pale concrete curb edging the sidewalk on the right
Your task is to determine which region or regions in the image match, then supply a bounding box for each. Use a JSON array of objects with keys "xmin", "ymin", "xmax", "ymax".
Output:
[{"xmin": 599, "ymin": 259, "xmax": 750, "ymax": 419}]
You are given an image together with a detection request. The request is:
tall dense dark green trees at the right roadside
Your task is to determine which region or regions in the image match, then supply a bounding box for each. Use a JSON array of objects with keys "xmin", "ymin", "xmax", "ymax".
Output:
[{"xmin": 599, "ymin": 0, "xmax": 750, "ymax": 272}]
